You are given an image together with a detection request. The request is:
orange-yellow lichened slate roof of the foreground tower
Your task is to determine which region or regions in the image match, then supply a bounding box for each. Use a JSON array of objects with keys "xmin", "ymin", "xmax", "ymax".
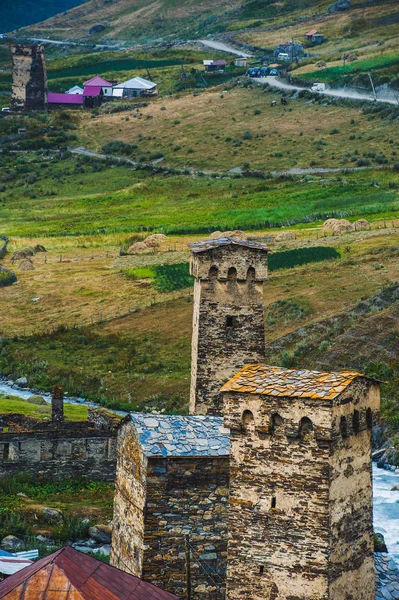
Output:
[{"xmin": 221, "ymin": 365, "xmax": 364, "ymax": 400}]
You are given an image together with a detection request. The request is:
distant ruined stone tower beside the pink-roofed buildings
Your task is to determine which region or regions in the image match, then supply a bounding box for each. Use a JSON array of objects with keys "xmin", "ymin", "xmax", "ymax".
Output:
[{"xmin": 11, "ymin": 44, "xmax": 47, "ymax": 110}]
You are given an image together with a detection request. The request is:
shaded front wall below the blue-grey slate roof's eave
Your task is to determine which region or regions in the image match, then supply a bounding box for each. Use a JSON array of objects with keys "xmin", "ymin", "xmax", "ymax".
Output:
[{"xmin": 142, "ymin": 457, "xmax": 229, "ymax": 600}]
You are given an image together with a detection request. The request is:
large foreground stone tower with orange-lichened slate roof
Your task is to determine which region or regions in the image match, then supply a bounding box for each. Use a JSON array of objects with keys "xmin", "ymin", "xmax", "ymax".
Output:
[{"xmin": 222, "ymin": 365, "xmax": 380, "ymax": 600}]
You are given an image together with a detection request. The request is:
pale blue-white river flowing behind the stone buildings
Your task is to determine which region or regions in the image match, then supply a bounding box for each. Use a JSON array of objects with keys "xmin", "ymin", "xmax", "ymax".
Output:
[{"xmin": 0, "ymin": 379, "xmax": 399, "ymax": 564}]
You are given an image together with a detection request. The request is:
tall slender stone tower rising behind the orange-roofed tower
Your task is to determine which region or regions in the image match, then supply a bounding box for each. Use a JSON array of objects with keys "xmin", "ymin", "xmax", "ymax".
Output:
[{"xmin": 190, "ymin": 238, "xmax": 268, "ymax": 415}]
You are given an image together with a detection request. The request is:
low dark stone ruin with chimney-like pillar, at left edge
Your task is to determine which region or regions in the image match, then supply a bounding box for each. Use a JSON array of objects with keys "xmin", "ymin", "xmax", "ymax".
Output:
[{"xmin": 0, "ymin": 388, "xmax": 120, "ymax": 481}]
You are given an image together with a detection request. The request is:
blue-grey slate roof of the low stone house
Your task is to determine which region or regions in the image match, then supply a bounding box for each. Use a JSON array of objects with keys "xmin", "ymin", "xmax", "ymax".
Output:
[{"xmin": 130, "ymin": 413, "xmax": 230, "ymax": 457}]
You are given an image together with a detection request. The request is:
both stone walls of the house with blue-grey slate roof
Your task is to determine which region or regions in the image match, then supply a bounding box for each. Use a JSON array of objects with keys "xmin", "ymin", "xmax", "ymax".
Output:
[{"xmin": 111, "ymin": 423, "xmax": 229, "ymax": 600}]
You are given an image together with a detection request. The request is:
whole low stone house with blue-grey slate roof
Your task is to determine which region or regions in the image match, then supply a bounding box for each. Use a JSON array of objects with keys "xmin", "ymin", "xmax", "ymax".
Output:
[{"xmin": 111, "ymin": 413, "xmax": 230, "ymax": 600}]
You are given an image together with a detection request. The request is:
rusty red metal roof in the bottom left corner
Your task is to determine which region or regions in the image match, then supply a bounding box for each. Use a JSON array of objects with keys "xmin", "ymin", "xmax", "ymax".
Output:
[{"xmin": 0, "ymin": 546, "xmax": 178, "ymax": 600}]
